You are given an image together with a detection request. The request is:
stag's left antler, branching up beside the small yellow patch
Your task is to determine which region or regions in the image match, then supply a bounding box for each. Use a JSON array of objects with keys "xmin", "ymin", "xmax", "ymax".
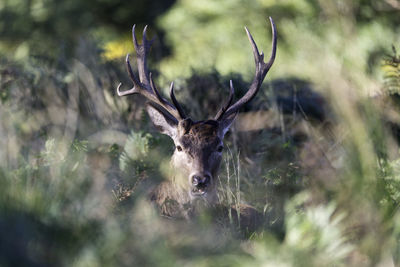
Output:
[{"xmin": 117, "ymin": 25, "xmax": 186, "ymax": 121}]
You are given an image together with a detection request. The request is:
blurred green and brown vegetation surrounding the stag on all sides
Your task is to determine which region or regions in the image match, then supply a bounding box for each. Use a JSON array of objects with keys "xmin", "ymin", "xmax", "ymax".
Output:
[{"xmin": 0, "ymin": 0, "xmax": 400, "ymax": 266}]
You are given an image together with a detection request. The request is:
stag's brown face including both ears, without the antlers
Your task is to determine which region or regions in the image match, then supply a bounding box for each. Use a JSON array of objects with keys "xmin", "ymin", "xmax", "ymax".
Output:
[{"xmin": 147, "ymin": 104, "xmax": 236, "ymax": 201}]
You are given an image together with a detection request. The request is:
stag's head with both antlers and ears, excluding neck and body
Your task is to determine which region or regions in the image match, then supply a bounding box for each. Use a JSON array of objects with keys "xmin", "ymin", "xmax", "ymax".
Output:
[{"xmin": 117, "ymin": 18, "xmax": 277, "ymax": 201}]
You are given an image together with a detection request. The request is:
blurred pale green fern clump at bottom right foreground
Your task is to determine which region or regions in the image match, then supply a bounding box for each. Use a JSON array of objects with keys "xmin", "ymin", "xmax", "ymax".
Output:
[{"xmin": 238, "ymin": 192, "xmax": 354, "ymax": 266}]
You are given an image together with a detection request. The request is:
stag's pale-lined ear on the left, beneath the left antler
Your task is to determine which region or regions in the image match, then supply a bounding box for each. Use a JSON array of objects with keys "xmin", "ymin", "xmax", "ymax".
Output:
[{"xmin": 146, "ymin": 103, "xmax": 178, "ymax": 139}]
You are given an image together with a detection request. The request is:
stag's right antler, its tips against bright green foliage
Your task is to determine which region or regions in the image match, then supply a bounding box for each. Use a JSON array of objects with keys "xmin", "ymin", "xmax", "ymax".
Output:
[{"xmin": 215, "ymin": 17, "xmax": 277, "ymax": 121}]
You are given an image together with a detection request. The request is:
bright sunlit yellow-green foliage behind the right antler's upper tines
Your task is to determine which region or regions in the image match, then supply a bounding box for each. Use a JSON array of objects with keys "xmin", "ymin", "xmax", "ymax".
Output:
[{"xmin": 158, "ymin": 0, "xmax": 399, "ymax": 97}]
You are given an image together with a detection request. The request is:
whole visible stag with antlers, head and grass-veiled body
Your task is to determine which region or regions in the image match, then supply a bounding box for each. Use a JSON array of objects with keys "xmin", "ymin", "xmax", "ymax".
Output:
[{"xmin": 117, "ymin": 17, "xmax": 277, "ymax": 232}]
